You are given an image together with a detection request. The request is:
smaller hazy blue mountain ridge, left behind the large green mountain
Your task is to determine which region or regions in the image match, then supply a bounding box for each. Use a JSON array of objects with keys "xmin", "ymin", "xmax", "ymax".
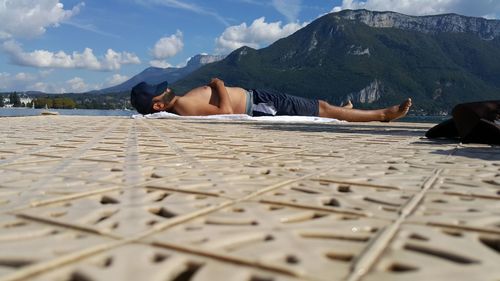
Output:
[{"xmin": 93, "ymin": 55, "xmax": 224, "ymax": 94}]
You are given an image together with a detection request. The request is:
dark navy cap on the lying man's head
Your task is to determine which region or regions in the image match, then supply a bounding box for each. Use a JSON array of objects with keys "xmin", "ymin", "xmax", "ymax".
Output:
[{"xmin": 130, "ymin": 81, "xmax": 168, "ymax": 114}]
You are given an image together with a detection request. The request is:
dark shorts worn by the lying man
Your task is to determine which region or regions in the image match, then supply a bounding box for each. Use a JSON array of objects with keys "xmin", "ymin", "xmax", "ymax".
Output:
[{"xmin": 247, "ymin": 89, "xmax": 319, "ymax": 116}]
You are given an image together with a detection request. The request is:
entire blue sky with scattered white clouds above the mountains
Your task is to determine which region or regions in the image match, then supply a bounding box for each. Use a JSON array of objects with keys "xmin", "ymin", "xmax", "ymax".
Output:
[{"xmin": 0, "ymin": 0, "xmax": 500, "ymax": 93}]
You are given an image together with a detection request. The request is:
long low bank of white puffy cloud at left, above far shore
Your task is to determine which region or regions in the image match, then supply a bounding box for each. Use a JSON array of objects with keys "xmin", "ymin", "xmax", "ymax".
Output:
[{"xmin": 2, "ymin": 40, "xmax": 141, "ymax": 71}]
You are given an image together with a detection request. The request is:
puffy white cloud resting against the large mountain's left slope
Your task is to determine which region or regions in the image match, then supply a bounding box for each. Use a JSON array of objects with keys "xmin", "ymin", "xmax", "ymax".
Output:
[{"xmin": 215, "ymin": 17, "xmax": 307, "ymax": 53}]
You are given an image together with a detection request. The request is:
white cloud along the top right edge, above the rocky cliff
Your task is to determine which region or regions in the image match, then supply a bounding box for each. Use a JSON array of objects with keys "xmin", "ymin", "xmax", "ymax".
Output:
[{"xmin": 333, "ymin": 0, "xmax": 500, "ymax": 18}]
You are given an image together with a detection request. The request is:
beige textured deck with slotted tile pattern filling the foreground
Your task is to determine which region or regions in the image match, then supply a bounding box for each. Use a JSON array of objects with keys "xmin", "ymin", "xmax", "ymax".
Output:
[{"xmin": 0, "ymin": 116, "xmax": 500, "ymax": 281}]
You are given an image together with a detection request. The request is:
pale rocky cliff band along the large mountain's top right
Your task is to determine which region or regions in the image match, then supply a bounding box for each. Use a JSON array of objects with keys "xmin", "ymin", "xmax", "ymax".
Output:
[{"xmin": 333, "ymin": 10, "xmax": 500, "ymax": 40}]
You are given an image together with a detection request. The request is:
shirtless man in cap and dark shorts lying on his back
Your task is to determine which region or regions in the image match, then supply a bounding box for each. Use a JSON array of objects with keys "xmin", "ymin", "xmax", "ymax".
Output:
[{"xmin": 130, "ymin": 78, "xmax": 411, "ymax": 122}]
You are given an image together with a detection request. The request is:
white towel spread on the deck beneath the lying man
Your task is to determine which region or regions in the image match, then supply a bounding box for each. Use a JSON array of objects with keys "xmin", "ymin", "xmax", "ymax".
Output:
[{"xmin": 132, "ymin": 111, "xmax": 345, "ymax": 123}]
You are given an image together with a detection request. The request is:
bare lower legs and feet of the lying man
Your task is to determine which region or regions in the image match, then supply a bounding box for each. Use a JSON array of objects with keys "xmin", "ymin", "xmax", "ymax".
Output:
[{"xmin": 319, "ymin": 99, "xmax": 411, "ymax": 122}]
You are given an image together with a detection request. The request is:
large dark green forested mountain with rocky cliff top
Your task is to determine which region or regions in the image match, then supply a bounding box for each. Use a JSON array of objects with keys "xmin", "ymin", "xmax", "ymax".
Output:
[{"xmin": 173, "ymin": 10, "xmax": 500, "ymax": 114}]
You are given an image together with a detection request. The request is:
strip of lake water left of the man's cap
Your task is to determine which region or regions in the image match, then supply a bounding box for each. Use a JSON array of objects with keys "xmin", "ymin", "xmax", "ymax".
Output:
[{"xmin": 0, "ymin": 107, "xmax": 137, "ymax": 117}]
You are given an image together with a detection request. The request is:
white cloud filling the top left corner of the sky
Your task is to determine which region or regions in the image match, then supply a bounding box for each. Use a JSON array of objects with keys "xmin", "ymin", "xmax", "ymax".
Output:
[{"xmin": 0, "ymin": 0, "xmax": 85, "ymax": 39}]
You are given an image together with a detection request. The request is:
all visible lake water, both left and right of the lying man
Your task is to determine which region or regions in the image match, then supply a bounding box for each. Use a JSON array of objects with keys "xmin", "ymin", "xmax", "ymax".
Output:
[{"xmin": 0, "ymin": 107, "xmax": 450, "ymax": 123}]
